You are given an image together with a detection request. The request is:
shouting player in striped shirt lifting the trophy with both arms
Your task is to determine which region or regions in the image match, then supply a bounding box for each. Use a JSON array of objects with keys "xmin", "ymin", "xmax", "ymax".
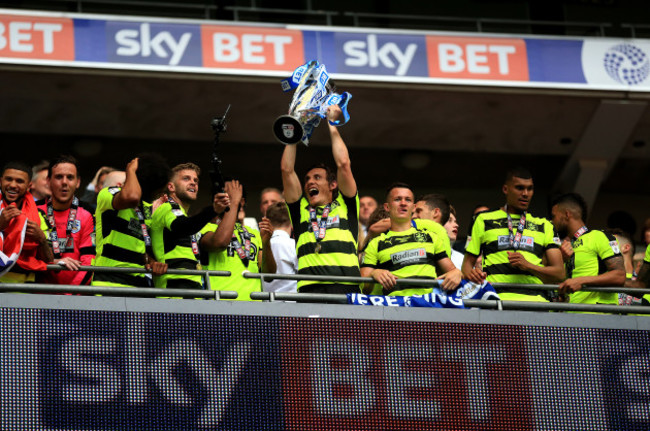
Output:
[{"xmin": 282, "ymin": 105, "xmax": 360, "ymax": 293}]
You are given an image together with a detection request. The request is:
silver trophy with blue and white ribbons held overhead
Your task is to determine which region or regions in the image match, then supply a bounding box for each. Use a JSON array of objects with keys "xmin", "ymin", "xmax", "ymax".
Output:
[{"xmin": 273, "ymin": 60, "xmax": 352, "ymax": 145}]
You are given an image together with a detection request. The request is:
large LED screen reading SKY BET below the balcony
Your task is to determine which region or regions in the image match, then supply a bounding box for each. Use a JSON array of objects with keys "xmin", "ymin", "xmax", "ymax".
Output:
[{"xmin": 0, "ymin": 306, "xmax": 650, "ymax": 431}]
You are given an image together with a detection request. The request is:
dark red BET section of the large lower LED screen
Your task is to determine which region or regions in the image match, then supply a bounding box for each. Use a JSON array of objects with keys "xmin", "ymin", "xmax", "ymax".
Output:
[{"xmin": 281, "ymin": 320, "xmax": 533, "ymax": 430}]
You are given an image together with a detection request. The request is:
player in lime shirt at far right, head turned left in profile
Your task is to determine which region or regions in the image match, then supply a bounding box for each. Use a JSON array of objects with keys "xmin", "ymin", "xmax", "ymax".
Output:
[{"xmin": 551, "ymin": 193, "xmax": 625, "ymax": 305}]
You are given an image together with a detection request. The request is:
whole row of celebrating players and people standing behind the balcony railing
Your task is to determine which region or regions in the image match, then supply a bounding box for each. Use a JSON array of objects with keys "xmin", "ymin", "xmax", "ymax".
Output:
[{"xmin": 0, "ymin": 106, "xmax": 650, "ymax": 304}]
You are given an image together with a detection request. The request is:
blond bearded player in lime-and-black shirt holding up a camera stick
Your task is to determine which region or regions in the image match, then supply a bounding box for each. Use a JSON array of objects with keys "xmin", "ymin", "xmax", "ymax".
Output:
[{"xmin": 151, "ymin": 163, "xmax": 230, "ymax": 289}]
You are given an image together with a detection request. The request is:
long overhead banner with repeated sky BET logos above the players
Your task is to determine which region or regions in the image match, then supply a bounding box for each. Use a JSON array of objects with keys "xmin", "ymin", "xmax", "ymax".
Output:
[{"xmin": 0, "ymin": 9, "xmax": 650, "ymax": 92}]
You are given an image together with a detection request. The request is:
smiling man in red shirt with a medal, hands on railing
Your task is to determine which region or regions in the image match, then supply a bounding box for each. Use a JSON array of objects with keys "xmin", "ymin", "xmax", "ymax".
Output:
[{"xmin": 38, "ymin": 155, "xmax": 95, "ymax": 285}]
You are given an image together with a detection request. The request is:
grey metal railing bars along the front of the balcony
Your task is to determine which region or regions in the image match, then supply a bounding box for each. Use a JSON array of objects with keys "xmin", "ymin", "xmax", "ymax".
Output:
[{"xmin": 0, "ymin": 265, "xmax": 650, "ymax": 314}]
